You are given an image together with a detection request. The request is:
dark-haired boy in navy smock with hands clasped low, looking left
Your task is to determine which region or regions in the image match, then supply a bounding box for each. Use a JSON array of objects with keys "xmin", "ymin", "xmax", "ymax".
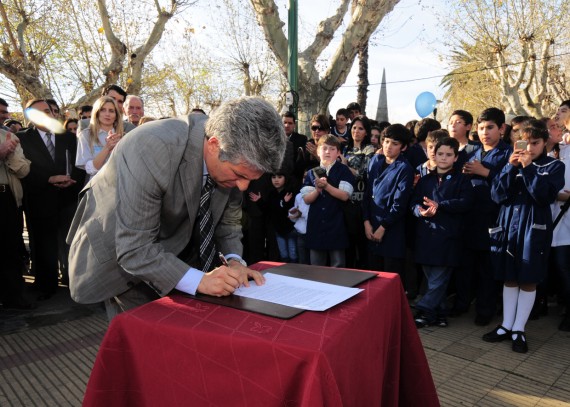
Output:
[{"xmin": 362, "ymin": 124, "xmax": 414, "ymax": 282}]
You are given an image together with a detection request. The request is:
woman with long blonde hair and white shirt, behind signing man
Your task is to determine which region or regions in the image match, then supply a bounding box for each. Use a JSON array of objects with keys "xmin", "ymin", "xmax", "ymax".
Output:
[{"xmin": 75, "ymin": 96, "xmax": 123, "ymax": 181}]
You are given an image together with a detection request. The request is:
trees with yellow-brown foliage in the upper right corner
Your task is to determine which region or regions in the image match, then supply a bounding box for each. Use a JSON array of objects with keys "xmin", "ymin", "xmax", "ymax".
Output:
[{"xmin": 442, "ymin": 0, "xmax": 570, "ymax": 117}]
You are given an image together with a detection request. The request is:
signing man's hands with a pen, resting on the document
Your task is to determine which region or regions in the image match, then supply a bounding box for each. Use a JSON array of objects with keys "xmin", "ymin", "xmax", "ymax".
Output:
[{"xmin": 197, "ymin": 260, "xmax": 265, "ymax": 297}]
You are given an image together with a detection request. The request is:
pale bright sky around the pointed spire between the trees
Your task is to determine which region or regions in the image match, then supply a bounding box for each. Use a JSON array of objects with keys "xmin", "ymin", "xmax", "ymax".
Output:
[{"xmin": 299, "ymin": 0, "xmax": 449, "ymax": 123}]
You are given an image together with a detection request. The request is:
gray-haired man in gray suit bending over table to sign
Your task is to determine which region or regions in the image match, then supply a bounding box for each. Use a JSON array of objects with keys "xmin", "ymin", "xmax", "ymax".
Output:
[{"xmin": 68, "ymin": 97, "xmax": 286, "ymax": 318}]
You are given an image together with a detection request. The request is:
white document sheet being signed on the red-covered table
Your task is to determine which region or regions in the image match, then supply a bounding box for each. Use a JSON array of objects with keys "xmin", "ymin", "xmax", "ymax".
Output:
[{"xmin": 234, "ymin": 273, "xmax": 363, "ymax": 311}]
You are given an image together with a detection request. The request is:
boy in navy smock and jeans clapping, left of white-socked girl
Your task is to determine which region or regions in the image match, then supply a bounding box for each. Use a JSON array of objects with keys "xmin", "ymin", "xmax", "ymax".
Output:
[{"xmin": 411, "ymin": 136, "xmax": 473, "ymax": 328}]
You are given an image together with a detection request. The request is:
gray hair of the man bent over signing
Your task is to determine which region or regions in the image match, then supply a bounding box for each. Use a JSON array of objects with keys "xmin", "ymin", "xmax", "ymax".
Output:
[{"xmin": 206, "ymin": 97, "xmax": 287, "ymax": 173}]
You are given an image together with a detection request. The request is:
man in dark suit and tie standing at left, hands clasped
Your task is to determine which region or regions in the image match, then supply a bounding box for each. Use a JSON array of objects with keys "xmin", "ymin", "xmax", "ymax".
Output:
[{"xmin": 17, "ymin": 99, "xmax": 83, "ymax": 300}]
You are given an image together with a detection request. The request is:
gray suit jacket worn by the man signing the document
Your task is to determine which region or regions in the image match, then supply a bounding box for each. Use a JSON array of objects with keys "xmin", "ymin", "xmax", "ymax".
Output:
[{"xmin": 68, "ymin": 115, "xmax": 242, "ymax": 303}]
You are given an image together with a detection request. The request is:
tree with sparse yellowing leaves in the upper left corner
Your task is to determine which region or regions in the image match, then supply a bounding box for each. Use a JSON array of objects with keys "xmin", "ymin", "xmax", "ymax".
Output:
[{"xmin": 0, "ymin": 0, "xmax": 194, "ymax": 105}]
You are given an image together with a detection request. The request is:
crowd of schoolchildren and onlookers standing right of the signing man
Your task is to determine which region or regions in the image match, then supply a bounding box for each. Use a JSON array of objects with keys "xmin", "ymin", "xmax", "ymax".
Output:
[{"xmin": 244, "ymin": 101, "xmax": 570, "ymax": 352}]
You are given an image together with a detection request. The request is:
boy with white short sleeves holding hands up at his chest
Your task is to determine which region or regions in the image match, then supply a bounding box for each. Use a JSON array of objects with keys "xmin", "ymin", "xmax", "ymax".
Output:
[{"xmin": 301, "ymin": 134, "xmax": 354, "ymax": 267}]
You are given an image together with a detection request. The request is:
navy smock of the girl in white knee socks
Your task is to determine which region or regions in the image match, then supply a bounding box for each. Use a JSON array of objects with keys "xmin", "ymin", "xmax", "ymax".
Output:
[{"xmin": 489, "ymin": 155, "xmax": 564, "ymax": 284}]
